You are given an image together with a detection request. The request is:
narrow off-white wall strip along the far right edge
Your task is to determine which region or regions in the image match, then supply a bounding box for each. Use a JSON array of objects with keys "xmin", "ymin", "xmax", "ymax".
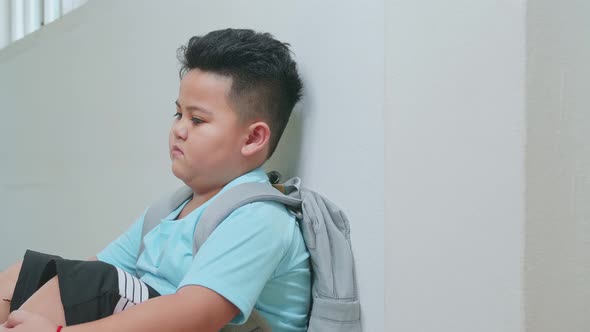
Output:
[{"xmin": 525, "ymin": 0, "xmax": 590, "ymax": 332}]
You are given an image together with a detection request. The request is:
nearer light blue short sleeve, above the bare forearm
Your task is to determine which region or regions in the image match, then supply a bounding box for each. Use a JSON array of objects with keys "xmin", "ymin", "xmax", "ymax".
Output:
[{"xmin": 178, "ymin": 202, "xmax": 294, "ymax": 324}]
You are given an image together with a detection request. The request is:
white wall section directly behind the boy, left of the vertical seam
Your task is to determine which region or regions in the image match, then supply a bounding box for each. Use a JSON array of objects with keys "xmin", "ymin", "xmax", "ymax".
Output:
[{"xmin": 0, "ymin": 0, "xmax": 384, "ymax": 331}]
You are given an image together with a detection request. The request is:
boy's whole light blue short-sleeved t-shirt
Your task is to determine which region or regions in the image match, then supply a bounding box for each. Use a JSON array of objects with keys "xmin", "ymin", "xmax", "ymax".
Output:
[{"xmin": 97, "ymin": 168, "xmax": 311, "ymax": 332}]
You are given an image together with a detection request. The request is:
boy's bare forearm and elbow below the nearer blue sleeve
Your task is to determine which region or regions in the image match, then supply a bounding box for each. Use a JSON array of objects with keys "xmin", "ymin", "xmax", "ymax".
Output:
[{"xmin": 62, "ymin": 286, "xmax": 238, "ymax": 332}]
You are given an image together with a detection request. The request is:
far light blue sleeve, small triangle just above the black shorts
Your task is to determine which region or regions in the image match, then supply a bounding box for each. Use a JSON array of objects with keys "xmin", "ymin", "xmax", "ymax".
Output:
[{"xmin": 96, "ymin": 213, "xmax": 145, "ymax": 275}]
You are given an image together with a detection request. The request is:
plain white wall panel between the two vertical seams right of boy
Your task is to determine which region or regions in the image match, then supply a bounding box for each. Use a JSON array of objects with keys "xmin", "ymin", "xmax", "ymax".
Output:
[{"xmin": 385, "ymin": 0, "xmax": 528, "ymax": 332}]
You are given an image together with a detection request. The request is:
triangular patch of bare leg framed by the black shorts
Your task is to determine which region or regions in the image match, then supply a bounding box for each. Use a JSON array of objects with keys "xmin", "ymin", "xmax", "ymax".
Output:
[{"xmin": 21, "ymin": 277, "xmax": 66, "ymax": 326}]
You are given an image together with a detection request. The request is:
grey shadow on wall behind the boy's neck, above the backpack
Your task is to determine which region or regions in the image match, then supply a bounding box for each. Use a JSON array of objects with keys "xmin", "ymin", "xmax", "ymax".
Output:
[{"xmin": 264, "ymin": 103, "xmax": 303, "ymax": 181}]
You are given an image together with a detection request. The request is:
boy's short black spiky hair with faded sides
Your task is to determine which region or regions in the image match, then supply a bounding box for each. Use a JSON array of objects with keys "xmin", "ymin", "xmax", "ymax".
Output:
[{"xmin": 177, "ymin": 29, "xmax": 303, "ymax": 158}]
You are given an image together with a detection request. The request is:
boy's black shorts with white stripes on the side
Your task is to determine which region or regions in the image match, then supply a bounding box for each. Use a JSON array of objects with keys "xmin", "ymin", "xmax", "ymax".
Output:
[{"xmin": 10, "ymin": 250, "xmax": 160, "ymax": 325}]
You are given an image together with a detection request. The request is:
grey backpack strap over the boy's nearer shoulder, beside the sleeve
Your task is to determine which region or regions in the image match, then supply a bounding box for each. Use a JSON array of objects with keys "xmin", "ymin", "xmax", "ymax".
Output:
[{"xmin": 193, "ymin": 181, "xmax": 301, "ymax": 255}]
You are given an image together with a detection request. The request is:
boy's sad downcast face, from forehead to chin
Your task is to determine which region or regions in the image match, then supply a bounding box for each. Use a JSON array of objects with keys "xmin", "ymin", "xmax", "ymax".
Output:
[{"xmin": 170, "ymin": 69, "xmax": 247, "ymax": 192}]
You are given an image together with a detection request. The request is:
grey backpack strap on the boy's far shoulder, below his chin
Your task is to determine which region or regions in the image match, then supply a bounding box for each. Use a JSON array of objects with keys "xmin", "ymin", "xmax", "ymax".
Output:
[{"xmin": 137, "ymin": 186, "xmax": 193, "ymax": 259}]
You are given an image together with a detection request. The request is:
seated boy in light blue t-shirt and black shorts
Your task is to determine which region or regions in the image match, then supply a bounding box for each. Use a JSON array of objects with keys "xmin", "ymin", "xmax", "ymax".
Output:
[{"xmin": 0, "ymin": 29, "xmax": 311, "ymax": 332}]
